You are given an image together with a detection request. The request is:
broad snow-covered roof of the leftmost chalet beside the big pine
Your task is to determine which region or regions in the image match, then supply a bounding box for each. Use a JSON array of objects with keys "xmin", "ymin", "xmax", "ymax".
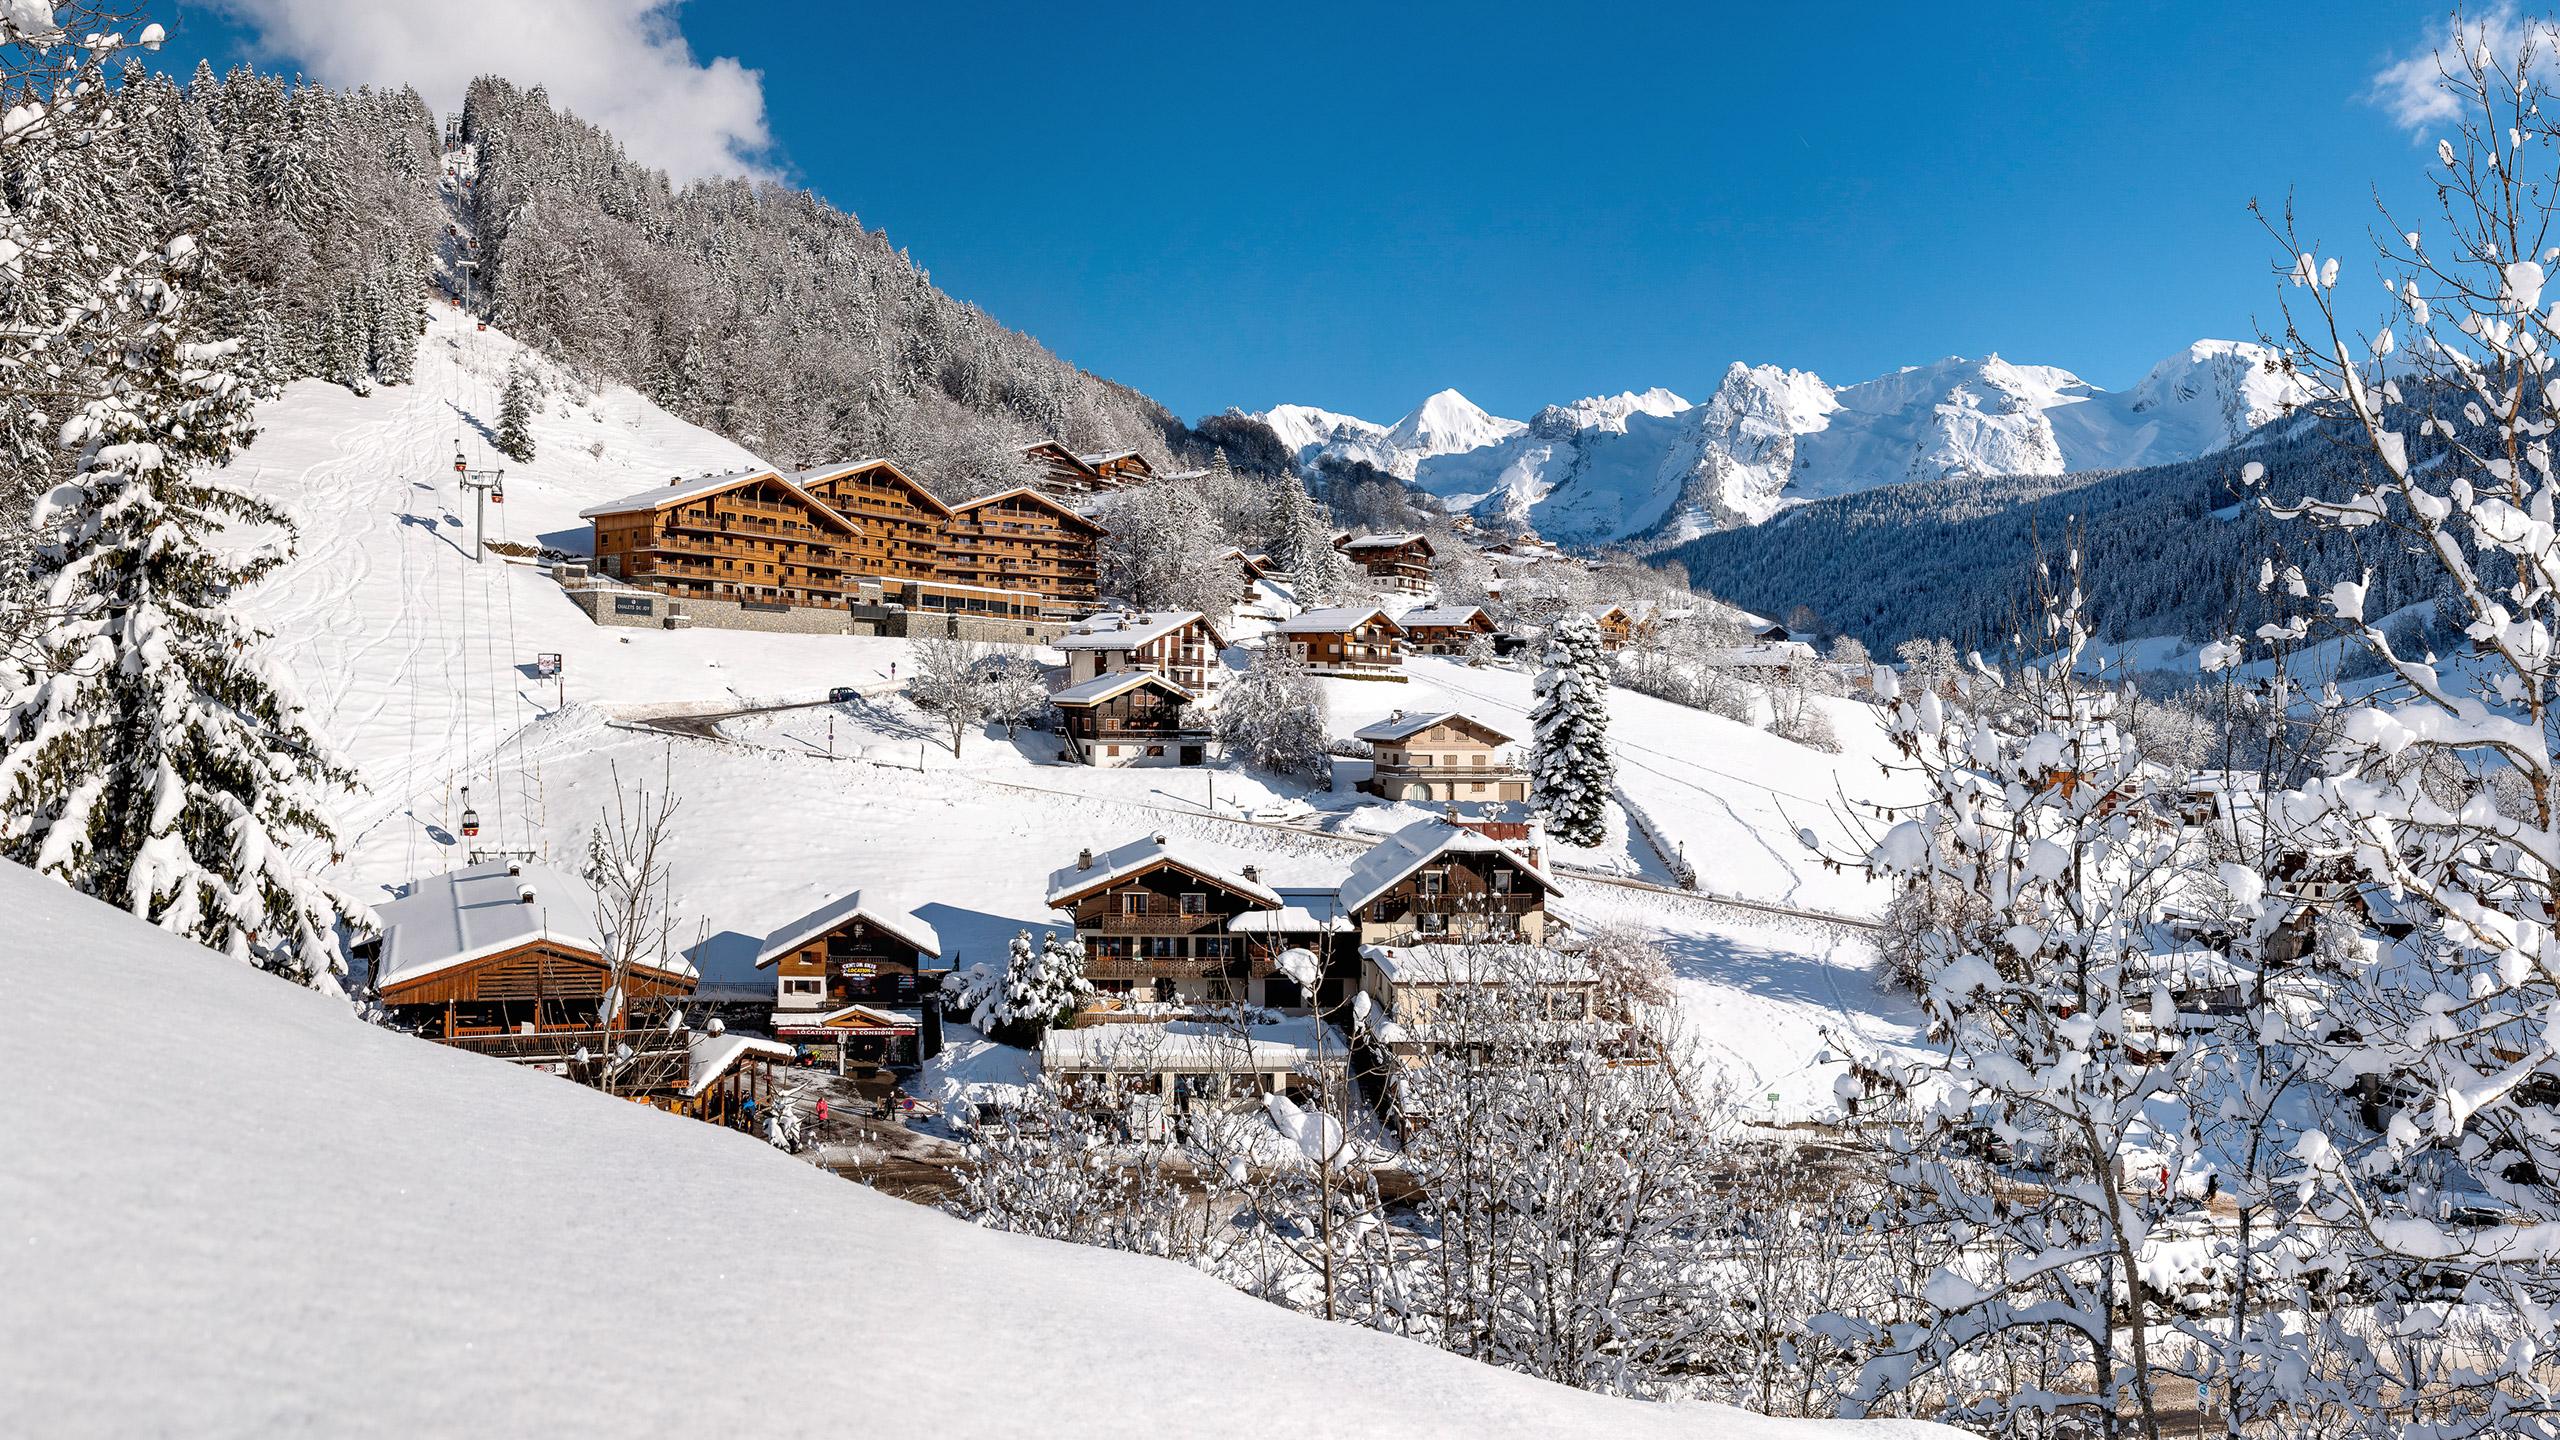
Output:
[{"xmin": 374, "ymin": 861, "xmax": 624, "ymax": 989}]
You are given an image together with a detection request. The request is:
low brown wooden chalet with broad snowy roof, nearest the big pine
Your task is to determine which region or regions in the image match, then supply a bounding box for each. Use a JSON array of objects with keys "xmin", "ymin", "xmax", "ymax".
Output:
[{"xmin": 374, "ymin": 861, "xmax": 694, "ymax": 1040}]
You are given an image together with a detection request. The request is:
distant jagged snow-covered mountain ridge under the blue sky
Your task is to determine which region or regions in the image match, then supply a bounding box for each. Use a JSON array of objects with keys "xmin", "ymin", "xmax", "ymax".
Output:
[{"xmin": 1254, "ymin": 338, "xmax": 2301, "ymax": 551}]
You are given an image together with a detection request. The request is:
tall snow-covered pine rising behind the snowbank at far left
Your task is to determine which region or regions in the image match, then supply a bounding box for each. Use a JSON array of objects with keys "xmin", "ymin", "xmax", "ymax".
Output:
[{"xmin": 0, "ymin": 236, "xmax": 369, "ymax": 989}]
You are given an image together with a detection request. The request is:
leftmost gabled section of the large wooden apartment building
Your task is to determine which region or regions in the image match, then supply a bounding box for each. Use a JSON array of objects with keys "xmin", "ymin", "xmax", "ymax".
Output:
[{"xmin": 579, "ymin": 469, "xmax": 860, "ymax": 605}]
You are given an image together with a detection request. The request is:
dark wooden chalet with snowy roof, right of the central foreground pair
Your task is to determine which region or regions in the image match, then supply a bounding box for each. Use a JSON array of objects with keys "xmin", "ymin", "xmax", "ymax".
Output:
[{"xmin": 1341, "ymin": 820, "xmax": 1556, "ymax": 945}]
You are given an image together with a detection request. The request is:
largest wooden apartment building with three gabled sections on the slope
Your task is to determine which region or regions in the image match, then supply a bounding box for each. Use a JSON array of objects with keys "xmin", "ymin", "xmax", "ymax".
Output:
[{"xmin": 579, "ymin": 446, "xmax": 1116, "ymax": 620}]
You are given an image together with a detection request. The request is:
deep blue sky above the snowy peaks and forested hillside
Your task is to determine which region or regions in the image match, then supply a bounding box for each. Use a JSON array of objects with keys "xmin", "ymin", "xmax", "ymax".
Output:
[{"xmin": 169, "ymin": 0, "xmax": 2442, "ymax": 420}]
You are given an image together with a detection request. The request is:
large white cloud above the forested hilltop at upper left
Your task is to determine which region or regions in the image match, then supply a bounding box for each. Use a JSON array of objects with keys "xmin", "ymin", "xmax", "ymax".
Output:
[{"xmin": 220, "ymin": 0, "xmax": 773, "ymax": 182}]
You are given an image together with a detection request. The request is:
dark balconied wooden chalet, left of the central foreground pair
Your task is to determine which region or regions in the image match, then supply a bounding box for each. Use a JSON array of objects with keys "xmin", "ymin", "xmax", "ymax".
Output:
[{"xmin": 1050, "ymin": 835, "xmax": 1303, "ymax": 1007}]
